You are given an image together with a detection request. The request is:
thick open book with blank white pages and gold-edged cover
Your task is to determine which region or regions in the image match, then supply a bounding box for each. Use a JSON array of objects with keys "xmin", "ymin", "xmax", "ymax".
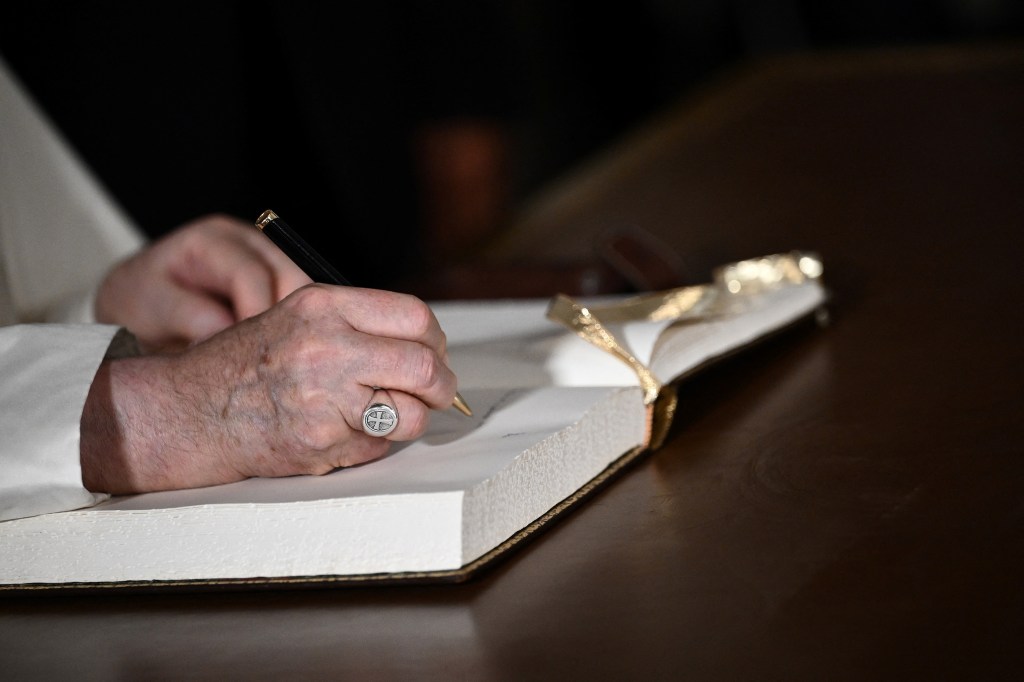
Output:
[{"xmin": 0, "ymin": 253, "xmax": 825, "ymax": 590}]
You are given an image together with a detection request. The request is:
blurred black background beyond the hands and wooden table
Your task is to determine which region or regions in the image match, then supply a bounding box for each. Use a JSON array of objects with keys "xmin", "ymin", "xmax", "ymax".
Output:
[{"xmin": 0, "ymin": 0, "xmax": 1024, "ymax": 295}]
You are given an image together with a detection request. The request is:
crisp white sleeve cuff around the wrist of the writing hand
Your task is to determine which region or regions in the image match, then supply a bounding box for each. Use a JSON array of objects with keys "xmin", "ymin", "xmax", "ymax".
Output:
[{"xmin": 0, "ymin": 324, "xmax": 118, "ymax": 520}]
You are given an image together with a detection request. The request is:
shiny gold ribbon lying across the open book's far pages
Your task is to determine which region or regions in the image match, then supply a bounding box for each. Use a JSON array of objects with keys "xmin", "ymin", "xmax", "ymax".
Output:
[{"xmin": 548, "ymin": 251, "xmax": 822, "ymax": 403}]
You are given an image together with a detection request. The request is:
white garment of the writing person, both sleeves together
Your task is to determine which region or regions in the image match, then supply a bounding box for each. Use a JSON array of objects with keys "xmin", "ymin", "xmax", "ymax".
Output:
[{"xmin": 0, "ymin": 60, "xmax": 143, "ymax": 520}]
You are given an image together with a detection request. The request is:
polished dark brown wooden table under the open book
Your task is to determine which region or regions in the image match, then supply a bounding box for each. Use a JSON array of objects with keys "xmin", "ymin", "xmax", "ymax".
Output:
[{"xmin": 0, "ymin": 47, "xmax": 1024, "ymax": 680}]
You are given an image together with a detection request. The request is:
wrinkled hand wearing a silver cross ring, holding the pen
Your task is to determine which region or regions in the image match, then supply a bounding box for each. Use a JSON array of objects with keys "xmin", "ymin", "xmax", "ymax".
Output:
[{"xmin": 81, "ymin": 285, "xmax": 456, "ymax": 494}]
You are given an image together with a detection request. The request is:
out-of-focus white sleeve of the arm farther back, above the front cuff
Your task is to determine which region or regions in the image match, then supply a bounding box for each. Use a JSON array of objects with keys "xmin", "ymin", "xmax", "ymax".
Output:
[{"xmin": 0, "ymin": 53, "xmax": 144, "ymax": 324}]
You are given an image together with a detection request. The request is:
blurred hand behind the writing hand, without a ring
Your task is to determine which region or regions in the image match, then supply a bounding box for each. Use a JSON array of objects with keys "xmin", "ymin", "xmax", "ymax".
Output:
[{"xmin": 96, "ymin": 215, "xmax": 309, "ymax": 350}]
